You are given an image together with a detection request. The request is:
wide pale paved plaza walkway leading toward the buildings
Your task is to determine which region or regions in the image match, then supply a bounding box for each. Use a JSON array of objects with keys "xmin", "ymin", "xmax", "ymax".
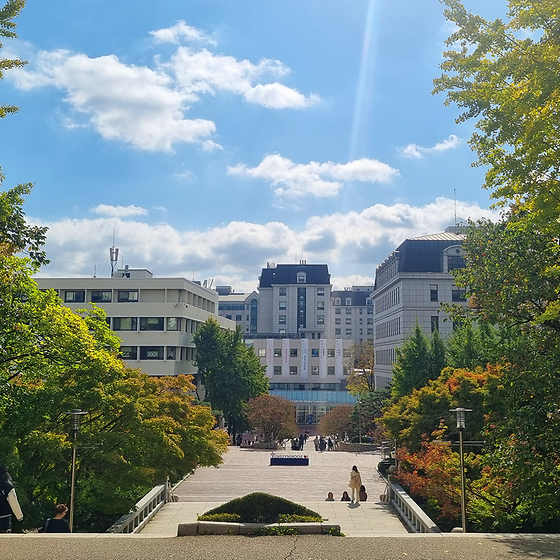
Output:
[{"xmin": 142, "ymin": 441, "xmax": 407, "ymax": 537}]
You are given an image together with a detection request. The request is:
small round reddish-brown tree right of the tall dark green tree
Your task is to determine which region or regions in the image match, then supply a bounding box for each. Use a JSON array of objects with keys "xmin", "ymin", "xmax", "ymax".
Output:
[{"xmin": 246, "ymin": 395, "xmax": 297, "ymax": 443}]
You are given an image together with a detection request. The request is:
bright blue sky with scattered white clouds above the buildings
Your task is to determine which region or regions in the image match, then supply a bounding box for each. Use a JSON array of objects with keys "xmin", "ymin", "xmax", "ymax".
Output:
[{"xmin": 0, "ymin": 0, "xmax": 505, "ymax": 291}]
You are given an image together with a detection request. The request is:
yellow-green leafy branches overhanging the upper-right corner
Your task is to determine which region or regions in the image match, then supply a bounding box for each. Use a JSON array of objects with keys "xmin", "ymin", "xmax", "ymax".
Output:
[{"xmin": 434, "ymin": 0, "xmax": 560, "ymax": 235}]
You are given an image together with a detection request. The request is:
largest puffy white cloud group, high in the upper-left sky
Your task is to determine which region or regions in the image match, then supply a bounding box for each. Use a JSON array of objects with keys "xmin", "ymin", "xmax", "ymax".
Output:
[{"xmin": 10, "ymin": 26, "xmax": 319, "ymax": 151}]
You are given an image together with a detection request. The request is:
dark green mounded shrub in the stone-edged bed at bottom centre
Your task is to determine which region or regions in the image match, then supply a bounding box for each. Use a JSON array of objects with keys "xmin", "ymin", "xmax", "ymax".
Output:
[{"xmin": 198, "ymin": 492, "xmax": 323, "ymax": 523}]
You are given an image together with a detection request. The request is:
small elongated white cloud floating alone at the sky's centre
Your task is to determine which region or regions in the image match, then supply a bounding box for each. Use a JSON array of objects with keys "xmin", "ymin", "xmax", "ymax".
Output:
[{"xmin": 228, "ymin": 154, "xmax": 398, "ymax": 198}]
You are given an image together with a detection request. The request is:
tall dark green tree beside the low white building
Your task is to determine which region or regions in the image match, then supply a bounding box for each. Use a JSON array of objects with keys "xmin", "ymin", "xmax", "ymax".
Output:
[{"xmin": 194, "ymin": 317, "xmax": 268, "ymax": 439}]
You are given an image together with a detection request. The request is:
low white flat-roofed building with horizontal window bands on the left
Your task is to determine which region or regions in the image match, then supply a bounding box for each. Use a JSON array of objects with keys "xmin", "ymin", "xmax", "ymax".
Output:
[{"xmin": 36, "ymin": 267, "xmax": 235, "ymax": 376}]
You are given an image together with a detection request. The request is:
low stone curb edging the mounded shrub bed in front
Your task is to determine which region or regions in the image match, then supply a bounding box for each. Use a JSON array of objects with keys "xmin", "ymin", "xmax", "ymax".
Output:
[{"xmin": 177, "ymin": 521, "xmax": 340, "ymax": 537}]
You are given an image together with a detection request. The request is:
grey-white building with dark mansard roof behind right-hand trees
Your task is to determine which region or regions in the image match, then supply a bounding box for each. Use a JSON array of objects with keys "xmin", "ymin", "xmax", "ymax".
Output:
[{"xmin": 371, "ymin": 227, "xmax": 465, "ymax": 388}]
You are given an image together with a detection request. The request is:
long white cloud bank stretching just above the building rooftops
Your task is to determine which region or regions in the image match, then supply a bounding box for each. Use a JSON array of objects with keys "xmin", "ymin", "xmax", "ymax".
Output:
[{"xmin": 32, "ymin": 198, "xmax": 495, "ymax": 282}]
